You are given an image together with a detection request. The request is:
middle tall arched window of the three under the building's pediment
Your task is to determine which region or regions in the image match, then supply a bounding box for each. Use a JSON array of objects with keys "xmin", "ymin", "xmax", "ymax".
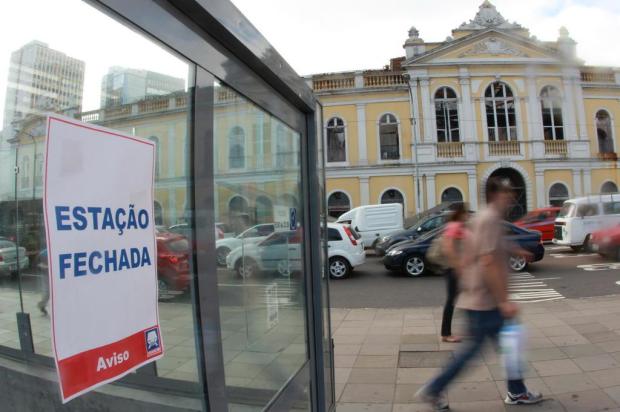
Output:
[{"xmin": 484, "ymin": 82, "xmax": 517, "ymax": 142}]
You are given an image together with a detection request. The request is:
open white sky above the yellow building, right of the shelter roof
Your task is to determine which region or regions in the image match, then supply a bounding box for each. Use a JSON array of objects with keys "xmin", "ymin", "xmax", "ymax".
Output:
[{"xmin": 232, "ymin": 0, "xmax": 620, "ymax": 75}]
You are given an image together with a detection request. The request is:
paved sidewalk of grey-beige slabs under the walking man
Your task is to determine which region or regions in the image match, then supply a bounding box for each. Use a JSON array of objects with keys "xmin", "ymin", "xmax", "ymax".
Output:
[{"xmin": 331, "ymin": 296, "xmax": 620, "ymax": 412}]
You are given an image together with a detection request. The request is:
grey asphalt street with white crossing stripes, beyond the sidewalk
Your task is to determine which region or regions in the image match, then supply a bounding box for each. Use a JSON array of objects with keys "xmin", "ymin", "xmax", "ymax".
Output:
[{"xmin": 330, "ymin": 245, "xmax": 620, "ymax": 308}]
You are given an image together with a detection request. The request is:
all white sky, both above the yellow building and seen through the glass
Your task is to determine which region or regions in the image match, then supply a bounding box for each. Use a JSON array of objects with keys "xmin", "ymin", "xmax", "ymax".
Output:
[{"xmin": 0, "ymin": 0, "xmax": 620, "ymax": 127}]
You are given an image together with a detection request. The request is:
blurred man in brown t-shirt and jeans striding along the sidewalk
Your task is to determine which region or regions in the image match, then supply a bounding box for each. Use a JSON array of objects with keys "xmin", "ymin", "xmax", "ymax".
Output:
[{"xmin": 416, "ymin": 178, "xmax": 542, "ymax": 411}]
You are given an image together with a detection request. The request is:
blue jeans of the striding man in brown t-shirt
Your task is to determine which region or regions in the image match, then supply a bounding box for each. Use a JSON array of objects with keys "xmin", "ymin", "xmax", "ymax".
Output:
[{"xmin": 428, "ymin": 309, "xmax": 527, "ymax": 395}]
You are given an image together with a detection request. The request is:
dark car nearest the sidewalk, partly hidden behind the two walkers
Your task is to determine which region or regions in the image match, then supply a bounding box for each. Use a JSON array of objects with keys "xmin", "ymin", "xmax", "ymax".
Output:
[{"xmin": 383, "ymin": 222, "xmax": 545, "ymax": 277}]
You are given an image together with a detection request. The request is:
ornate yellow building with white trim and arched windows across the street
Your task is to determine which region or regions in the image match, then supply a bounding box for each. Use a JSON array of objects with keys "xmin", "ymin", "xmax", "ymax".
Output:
[{"xmin": 307, "ymin": 1, "xmax": 620, "ymax": 219}]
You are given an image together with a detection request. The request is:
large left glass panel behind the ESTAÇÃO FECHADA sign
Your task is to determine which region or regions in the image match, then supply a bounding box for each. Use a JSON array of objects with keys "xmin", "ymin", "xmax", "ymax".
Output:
[{"xmin": 0, "ymin": 0, "xmax": 198, "ymax": 382}]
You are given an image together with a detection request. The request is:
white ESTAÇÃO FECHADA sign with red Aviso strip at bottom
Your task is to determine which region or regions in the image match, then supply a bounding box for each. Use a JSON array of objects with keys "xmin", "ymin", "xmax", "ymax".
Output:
[{"xmin": 44, "ymin": 116, "xmax": 164, "ymax": 402}]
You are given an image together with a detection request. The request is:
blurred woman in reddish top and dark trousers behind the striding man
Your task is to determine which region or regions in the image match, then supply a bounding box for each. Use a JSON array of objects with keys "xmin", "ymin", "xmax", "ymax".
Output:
[{"xmin": 441, "ymin": 203, "xmax": 468, "ymax": 342}]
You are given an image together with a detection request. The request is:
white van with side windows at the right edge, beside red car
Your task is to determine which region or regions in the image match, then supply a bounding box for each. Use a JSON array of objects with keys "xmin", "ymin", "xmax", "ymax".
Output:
[{"xmin": 553, "ymin": 194, "xmax": 620, "ymax": 251}]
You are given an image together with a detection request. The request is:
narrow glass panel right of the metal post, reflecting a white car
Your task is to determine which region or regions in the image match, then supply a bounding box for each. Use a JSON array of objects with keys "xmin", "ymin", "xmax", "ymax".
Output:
[{"xmin": 214, "ymin": 84, "xmax": 308, "ymax": 410}]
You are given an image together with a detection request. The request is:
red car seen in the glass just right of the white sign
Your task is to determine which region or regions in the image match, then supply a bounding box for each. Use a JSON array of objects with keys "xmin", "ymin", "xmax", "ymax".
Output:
[{"xmin": 155, "ymin": 230, "xmax": 191, "ymax": 297}]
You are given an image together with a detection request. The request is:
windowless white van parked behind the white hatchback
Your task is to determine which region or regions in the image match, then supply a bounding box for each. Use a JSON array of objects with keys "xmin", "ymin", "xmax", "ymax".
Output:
[{"xmin": 336, "ymin": 203, "xmax": 403, "ymax": 248}]
